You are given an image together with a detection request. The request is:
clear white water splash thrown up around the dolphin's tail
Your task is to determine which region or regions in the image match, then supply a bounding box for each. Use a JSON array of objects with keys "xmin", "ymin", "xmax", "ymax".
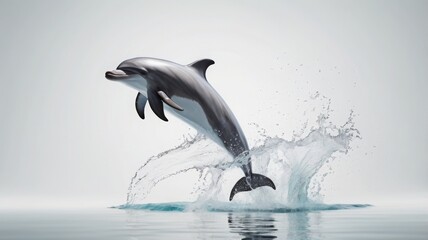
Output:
[{"xmin": 120, "ymin": 94, "xmax": 366, "ymax": 212}]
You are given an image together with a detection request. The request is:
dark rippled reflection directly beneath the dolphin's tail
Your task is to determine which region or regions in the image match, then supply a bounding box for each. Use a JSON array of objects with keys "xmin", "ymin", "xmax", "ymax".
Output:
[{"xmin": 228, "ymin": 213, "xmax": 278, "ymax": 239}]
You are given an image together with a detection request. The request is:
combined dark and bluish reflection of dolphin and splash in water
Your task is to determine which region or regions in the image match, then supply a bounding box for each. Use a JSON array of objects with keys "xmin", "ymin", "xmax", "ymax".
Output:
[{"xmin": 228, "ymin": 212, "xmax": 322, "ymax": 240}]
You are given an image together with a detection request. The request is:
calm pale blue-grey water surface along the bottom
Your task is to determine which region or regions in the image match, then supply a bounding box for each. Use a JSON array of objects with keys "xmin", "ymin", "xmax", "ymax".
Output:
[{"xmin": 0, "ymin": 207, "xmax": 428, "ymax": 240}]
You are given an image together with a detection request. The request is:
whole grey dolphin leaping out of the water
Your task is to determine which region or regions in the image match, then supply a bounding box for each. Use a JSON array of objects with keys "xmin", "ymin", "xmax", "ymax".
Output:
[{"xmin": 105, "ymin": 58, "xmax": 275, "ymax": 201}]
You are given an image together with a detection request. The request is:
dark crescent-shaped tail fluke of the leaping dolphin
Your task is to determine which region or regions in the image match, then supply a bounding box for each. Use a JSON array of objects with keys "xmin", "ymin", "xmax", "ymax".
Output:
[{"xmin": 229, "ymin": 173, "xmax": 276, "ymax": 201}]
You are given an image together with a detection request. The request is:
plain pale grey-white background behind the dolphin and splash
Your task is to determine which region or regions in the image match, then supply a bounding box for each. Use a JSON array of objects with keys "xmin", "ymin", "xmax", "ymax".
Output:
[{"xmin": 0, "ymin": 0, "xmax": 428, "ymax": 208}]
